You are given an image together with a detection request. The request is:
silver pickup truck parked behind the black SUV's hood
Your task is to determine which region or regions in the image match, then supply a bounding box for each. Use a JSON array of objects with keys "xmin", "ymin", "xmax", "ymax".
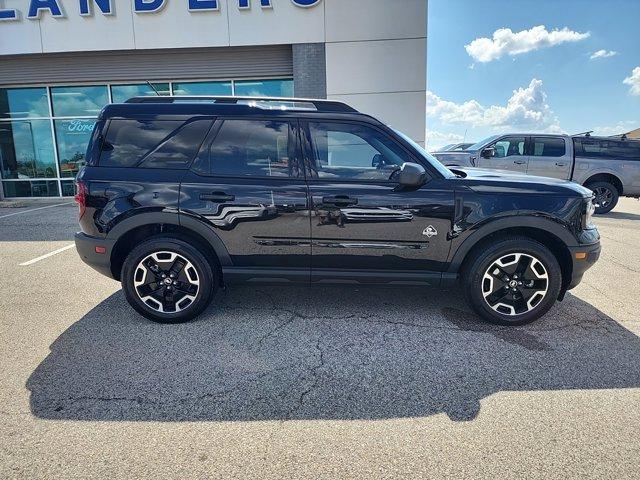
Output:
[{"xmin": 433, "ymin": 133, "xmax": 640, "ymax": 213}]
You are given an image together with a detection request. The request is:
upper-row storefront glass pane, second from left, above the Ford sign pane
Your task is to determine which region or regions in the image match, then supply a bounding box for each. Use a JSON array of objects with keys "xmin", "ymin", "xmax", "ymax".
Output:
[{"xmin": 51, "ymin": 85, "xmax": 109, "ymax": 117}]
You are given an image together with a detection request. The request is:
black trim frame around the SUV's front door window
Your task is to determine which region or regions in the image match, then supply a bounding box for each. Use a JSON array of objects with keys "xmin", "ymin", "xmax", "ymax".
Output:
[{"xmin": 300, "ymin": 117, "xmax": 424, "ymax": 186}]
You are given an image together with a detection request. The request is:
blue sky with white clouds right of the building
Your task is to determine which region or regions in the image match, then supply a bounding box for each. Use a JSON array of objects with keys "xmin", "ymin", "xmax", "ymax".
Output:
[{"xmin": 427, "ymin": 0, "xmax": 640, "ymax": 148}]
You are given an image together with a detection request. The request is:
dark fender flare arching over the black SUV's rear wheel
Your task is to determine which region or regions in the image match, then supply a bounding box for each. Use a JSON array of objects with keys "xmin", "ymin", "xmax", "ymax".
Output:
[{"xmin": 107, "ymin": 210, "xmax": 233, "ymax": 267}]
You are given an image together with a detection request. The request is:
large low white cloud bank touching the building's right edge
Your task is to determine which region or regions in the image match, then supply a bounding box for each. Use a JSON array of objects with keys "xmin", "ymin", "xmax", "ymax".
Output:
[{"xmin": 427, "ymin": 78, "xmax": 561, "ymax": 132}]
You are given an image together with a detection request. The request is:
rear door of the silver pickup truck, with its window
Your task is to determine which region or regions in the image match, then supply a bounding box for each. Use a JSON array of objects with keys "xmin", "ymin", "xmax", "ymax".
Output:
[{"xmin": 527, "ymin": 136, "xmax": 573, "ymax": 180}]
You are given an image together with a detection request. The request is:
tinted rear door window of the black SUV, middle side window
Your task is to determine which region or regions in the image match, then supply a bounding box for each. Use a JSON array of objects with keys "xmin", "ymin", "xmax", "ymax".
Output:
[{"xmin": 193, "ymin": 119, "xmax": 301, "ymax": 177}]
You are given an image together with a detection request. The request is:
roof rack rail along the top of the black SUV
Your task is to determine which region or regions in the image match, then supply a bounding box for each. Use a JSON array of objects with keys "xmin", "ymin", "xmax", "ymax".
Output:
[{"xmin": 125, "ymin": 95, "xmax": 359, "ymax": 113}]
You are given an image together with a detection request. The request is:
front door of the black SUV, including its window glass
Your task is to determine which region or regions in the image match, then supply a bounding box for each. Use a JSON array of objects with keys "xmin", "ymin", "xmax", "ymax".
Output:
[{"xmin": 302, "ymin": 121, "xmax": 453, "ymax": 283}]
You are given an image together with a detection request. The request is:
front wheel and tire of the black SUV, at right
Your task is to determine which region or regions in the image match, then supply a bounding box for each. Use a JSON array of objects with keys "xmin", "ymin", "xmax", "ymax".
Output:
[{"xmin": 462, "ymin": 237, "xmax": 562, "ymax": 325}]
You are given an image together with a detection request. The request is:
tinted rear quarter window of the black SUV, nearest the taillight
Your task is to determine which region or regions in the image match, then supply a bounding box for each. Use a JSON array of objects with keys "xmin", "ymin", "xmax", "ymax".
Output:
[{"xmin": 99, "ymin": 119, "xmax": 212, "ymax": 169}]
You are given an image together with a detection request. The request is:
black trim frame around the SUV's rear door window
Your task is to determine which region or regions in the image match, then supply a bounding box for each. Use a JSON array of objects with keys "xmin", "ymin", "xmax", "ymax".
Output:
[{"xmin": 188, "ymin": 115, "xmax": 307, "ymax": 183}]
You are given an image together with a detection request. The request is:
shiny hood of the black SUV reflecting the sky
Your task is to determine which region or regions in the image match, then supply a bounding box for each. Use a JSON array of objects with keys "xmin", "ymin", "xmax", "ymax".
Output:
[{"xmin": 451, "ymin": 167, "xmax": 593, "ymax": 197}]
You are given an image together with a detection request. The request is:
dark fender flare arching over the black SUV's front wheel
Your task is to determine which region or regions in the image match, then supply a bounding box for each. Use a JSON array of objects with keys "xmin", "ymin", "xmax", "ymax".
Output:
[{"xmin": 447, "ymin": 215, "xmax": 578, "ymax": 273}]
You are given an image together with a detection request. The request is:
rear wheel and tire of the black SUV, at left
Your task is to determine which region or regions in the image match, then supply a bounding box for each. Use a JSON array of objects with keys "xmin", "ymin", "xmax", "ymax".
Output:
[{"xmin": 121, "ymin": 237, "xmax": 217, "ymax": 323}]
